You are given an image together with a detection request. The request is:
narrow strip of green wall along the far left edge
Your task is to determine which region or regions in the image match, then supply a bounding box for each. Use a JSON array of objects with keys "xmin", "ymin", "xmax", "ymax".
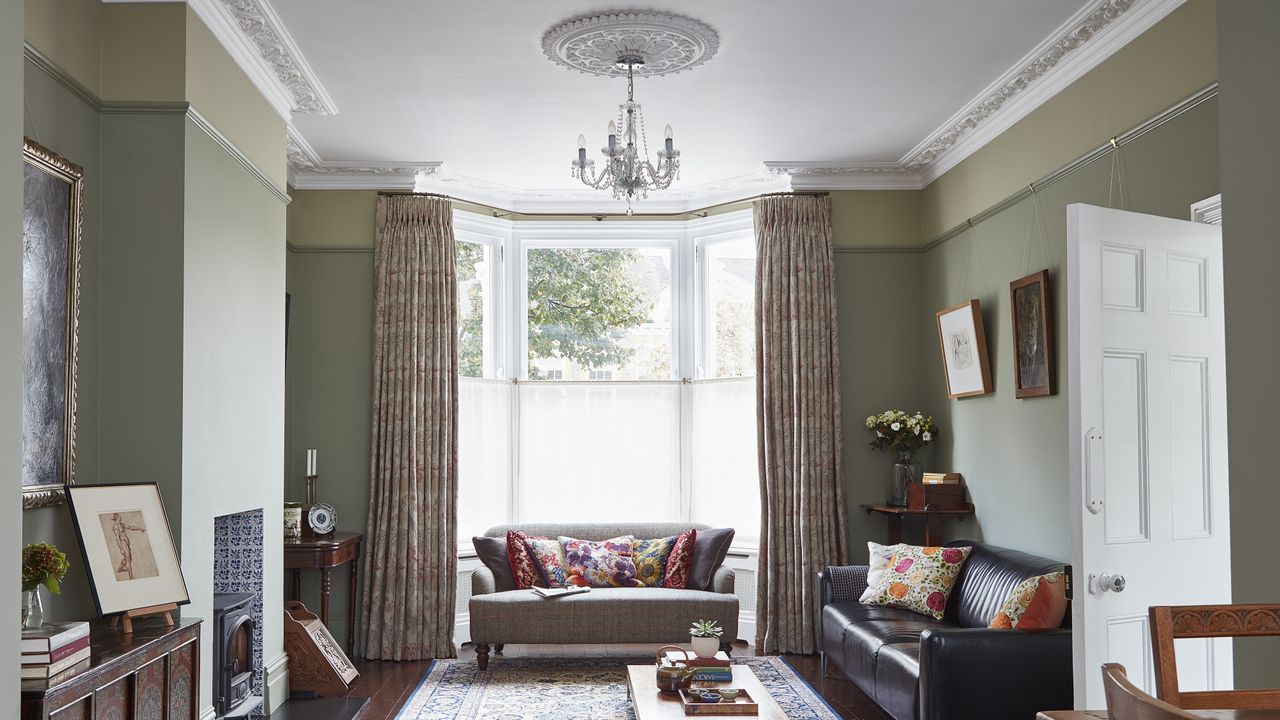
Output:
[{"xmin": 0, "ymin": 0, "xmax": 23, "ymax": 720}]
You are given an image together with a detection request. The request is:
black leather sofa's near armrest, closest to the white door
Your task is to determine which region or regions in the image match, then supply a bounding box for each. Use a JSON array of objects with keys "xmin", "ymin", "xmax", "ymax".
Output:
[{"xmin": 920, "ymin": 628, "xmax": 1074, "ymax": 720}]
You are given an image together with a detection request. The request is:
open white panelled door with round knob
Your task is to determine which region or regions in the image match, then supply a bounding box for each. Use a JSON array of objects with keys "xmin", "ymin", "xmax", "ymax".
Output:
[{"xmin": 1066, "ymin": 205, "xmax": 1233, "ymax": 708}]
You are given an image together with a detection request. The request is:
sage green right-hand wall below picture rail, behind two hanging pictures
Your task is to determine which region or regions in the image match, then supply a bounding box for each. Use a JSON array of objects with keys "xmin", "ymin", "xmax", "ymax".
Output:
[{"xmin": 919, "ymin": 100, "xmax": 1230, "ymax": 561}]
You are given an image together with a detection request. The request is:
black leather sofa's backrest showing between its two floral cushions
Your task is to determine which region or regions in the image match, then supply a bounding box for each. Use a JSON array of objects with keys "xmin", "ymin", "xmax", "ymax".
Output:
[{"xmin": 946, "ymin": 541, "xmax": 1071, "ymax": 628}]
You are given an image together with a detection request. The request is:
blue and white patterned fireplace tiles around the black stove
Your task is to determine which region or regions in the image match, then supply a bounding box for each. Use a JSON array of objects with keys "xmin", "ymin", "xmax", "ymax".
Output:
[{"xmin": 214, "ymin": 510, "xmax": 262, "ymax": 697}]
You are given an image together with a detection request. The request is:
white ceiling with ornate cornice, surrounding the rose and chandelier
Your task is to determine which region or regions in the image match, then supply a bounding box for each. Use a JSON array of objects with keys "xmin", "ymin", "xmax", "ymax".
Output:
[{"xmin": 187, "ymin": 0, "xmax": 1184, "ymax": 209}]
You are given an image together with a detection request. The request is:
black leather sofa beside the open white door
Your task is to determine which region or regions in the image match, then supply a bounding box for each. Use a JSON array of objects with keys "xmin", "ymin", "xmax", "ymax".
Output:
[{"xmin": 818, "ymin": 541, "xmax": 1073, "ymax": 720}]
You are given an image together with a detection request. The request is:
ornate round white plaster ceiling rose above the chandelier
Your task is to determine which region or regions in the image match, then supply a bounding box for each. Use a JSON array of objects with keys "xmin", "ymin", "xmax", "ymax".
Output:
[{"xmin": 543, "ymin": 10, "xmax": 719, "ymax": 77}]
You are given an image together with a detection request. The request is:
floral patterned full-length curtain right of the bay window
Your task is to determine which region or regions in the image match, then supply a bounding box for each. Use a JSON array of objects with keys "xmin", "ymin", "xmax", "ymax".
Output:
[{"xmin": 755, "ymin": 195, "xmax": 847, "ymax": 653}]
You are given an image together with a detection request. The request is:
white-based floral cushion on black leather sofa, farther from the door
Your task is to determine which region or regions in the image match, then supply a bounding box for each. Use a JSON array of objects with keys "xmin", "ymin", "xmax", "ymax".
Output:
[{"xmin": 863, "ymin": 544, "xmax": 973, "ymax": 620}]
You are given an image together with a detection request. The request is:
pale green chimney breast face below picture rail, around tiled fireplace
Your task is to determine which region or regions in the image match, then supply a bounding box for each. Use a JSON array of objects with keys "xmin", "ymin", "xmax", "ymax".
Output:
[{"xmin": 181, "ymin": 118, "xmax": 285, "ymax": 698}]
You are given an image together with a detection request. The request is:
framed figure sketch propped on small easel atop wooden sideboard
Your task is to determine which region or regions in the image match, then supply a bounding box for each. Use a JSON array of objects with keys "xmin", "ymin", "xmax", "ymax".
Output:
[{"xmin": 67, "ymin": 483, "xmax": 189, "ymax": 615}]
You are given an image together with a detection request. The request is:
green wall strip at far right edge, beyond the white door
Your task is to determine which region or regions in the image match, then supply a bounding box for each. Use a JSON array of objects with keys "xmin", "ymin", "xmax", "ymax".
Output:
[{"xmin": 1217, "ymin": 0, "xmax": 1280, "ymax": 688}]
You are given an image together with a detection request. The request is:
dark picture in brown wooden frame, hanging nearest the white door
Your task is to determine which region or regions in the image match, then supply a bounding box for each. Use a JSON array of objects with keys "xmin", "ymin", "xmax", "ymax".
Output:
[{"xmin": 1009, "ymin": 270, "xmax": 1056, "ymax": 397}]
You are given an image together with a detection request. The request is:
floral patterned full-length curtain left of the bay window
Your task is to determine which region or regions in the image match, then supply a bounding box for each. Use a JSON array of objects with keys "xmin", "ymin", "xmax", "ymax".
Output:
[{"xmin": 362, "ymin": 196, "xmax": 458, "ymax": 660}]
